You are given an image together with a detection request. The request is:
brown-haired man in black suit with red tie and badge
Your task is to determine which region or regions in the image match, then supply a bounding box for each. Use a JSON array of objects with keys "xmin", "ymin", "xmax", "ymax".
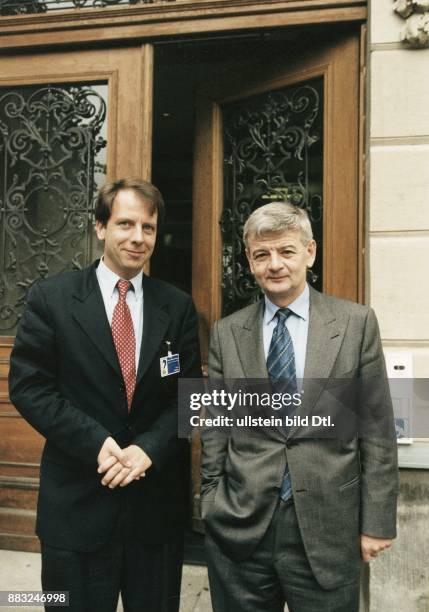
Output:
[{"xmin": 9, "ymin": 179, "xmax": 200, "ymax": 612}]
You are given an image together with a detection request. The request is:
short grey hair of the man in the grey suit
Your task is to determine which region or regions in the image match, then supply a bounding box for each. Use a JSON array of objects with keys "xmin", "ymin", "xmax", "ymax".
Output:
[{"xmin": 243, "ymin": 202, "xmax": 313, "ymax": 248}]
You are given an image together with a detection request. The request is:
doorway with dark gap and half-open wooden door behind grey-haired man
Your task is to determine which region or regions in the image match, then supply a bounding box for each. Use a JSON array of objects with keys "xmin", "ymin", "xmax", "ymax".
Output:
[{"xmin": 151, "ymin": 26, "xmax": 362, "ymax": 529}]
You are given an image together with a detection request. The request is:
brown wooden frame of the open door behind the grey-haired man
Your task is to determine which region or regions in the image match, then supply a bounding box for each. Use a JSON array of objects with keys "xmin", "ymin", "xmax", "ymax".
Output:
[{"xmin": 192, "ymin": 31, "xmax": 363, "ymax": 362}]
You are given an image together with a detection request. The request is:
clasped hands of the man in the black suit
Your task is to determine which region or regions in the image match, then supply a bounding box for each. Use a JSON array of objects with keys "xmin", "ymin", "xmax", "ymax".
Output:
[{"xmin": 97, "ymin": 437, "xmax": 152, "ymax": 489}]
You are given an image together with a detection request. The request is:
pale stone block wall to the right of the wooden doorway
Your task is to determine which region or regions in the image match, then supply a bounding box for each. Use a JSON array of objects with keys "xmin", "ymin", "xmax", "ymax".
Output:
[{"xmin": 367, "ymin": 0, "xmax": 429, "ymax": 612}]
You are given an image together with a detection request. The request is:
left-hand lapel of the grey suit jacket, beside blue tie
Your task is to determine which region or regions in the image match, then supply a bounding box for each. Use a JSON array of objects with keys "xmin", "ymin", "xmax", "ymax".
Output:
[{"xmin": 231, "ymin": 300, "xmax": 268, "ymax": 379}]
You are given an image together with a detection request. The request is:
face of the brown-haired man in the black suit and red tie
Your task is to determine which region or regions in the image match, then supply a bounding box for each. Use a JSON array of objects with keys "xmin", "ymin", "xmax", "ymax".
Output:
[{"xmin": 96, "ymin": 189, "xmax": 158, "ymax": 280}]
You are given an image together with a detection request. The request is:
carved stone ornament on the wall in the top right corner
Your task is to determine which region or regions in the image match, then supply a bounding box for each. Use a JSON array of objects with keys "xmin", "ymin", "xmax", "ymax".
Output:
[{"xmin": 393, "ymin": 0, "xmax": 429, "ymax": 49}]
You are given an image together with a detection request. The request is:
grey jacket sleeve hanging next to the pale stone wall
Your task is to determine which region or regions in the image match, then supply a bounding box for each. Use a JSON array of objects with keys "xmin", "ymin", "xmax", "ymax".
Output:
[{"xmin": 359, "ymin": 310, "xmax": 398, "ymax": 538}]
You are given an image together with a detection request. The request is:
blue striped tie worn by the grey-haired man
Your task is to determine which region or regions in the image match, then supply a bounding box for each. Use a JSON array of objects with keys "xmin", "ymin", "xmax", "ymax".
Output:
[{"xmin": 267, "ymin": 308, "xmax": 297, "ymax": 501}]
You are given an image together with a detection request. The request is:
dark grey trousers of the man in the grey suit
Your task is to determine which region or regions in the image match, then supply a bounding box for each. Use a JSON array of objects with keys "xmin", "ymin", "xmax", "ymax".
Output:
[{"xmin": 206, "ymin": 501, "xmax": 359, "ymax": 612}]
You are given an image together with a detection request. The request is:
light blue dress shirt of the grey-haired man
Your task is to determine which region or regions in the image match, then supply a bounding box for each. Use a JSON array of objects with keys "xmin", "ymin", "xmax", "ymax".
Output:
[{"xmin": 262, "ymin": 284, "xmax": 310, "ymax": 380}]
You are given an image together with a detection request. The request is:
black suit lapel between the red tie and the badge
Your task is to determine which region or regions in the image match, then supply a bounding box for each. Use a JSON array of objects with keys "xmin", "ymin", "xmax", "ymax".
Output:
[{"xmin": 136, "ymin": 275, "xmax": 174, "ymax": 385}]
